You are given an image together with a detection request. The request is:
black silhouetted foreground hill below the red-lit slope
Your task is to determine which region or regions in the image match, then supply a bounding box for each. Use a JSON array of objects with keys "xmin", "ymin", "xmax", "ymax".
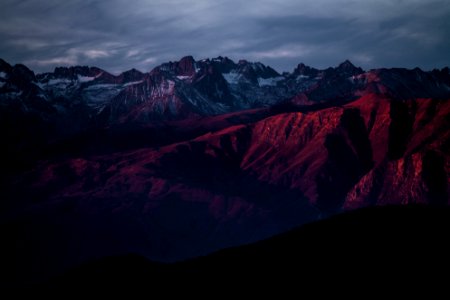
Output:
[{"xmin": 29, "ymin": 206, "xmax": 450, "ymax": 296}]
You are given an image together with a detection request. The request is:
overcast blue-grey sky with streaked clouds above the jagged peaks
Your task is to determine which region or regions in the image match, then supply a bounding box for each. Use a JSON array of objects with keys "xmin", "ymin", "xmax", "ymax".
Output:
[{"xmin": 0, "ymin": 0, "xmax": 450, "ymax": 73}]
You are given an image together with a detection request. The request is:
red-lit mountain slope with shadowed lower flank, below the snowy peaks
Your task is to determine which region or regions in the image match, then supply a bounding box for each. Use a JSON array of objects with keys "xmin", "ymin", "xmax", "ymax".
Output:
[{"xmin": 6, "ymin": 94, "xmax": 450, "ymax": 265}]
